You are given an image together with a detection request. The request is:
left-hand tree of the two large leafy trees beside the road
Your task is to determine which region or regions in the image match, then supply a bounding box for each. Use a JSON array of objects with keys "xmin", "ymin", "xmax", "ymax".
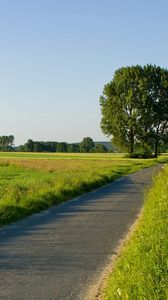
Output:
[{"xmin": 100, "ymin": 66, "xmax": 142, "ymax": 153}]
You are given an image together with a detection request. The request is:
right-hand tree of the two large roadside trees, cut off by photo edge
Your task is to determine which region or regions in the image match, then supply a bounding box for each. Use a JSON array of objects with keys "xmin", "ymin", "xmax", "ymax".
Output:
[{"xmin": 140, "ymin": 65, "xmax": 168, "ymax": 157}]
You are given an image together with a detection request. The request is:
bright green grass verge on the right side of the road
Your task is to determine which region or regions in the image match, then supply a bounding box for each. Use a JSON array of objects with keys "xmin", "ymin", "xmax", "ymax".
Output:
[{"xmin": 102, "ymin": 166, "xmax": 168, "ymax": 300}]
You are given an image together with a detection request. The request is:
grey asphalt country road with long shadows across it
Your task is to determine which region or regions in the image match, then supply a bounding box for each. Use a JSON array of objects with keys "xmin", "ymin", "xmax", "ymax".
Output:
[{"xmin": 0, "ymin": 165, "xmax": 161, "ymax": 300}]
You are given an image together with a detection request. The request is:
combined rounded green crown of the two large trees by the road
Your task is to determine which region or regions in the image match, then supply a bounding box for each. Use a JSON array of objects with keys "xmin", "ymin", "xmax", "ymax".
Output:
[{"xmin": 100, "ymin": 65, "xmax": 168, "ymax": 157}]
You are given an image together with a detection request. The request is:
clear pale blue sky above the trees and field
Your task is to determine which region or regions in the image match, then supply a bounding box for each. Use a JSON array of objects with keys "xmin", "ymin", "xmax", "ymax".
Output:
[{"xmin": 0, "ymin": 0, "xmax": 168, "ymax": 144}]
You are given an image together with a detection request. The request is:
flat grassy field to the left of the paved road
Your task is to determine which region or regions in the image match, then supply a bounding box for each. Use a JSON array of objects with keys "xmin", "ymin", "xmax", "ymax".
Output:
[{"xmin": 0, "ymin": 153, "xmax": 167, "ymax": 226}]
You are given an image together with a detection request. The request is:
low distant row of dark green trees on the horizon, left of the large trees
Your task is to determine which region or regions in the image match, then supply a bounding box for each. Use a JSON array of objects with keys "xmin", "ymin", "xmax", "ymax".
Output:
[{"xmin": 16, "ymin": 137, "xmax": 109, "ymax": 153}]
